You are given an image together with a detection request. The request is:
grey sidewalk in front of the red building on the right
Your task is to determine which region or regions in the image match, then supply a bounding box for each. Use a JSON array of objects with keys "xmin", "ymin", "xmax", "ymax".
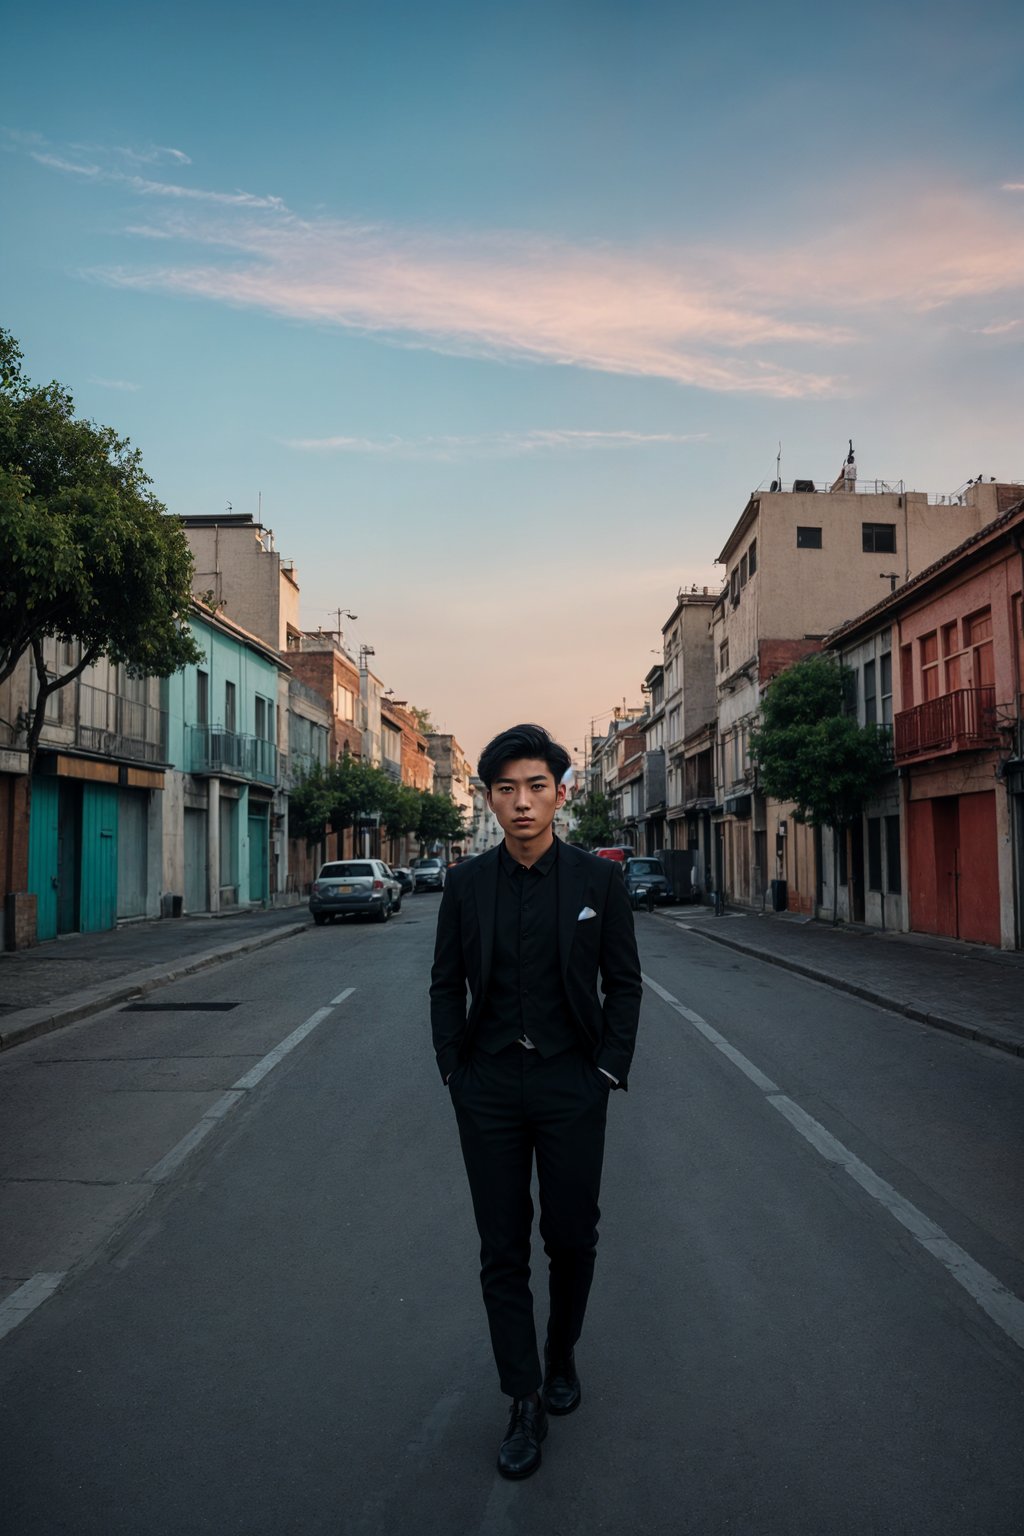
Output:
[{"xmin": 659, "ymin": 906, "xmax": 1024, "ymax": 1055}]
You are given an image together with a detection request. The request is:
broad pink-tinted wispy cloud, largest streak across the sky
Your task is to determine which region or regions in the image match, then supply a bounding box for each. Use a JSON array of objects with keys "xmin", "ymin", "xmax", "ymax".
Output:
[{"xmin": 28, "ymin": 134, "xmax": 1024, "ymax": 402}]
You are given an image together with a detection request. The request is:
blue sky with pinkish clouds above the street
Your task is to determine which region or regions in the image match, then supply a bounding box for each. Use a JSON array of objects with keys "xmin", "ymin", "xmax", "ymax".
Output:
[{"xmin": 0, "ymin": 0, "xmax": 1024, "ymax": 753}]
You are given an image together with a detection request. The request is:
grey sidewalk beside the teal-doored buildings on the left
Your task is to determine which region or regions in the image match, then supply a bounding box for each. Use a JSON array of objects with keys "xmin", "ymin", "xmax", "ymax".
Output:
[{"xmin": 0, "ymin": 903, "xmax": 309, "ymax": 1049}]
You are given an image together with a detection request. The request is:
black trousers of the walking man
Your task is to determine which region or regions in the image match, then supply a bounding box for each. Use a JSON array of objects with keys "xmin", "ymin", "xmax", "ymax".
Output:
[{"xmin": 448, "ymin": 1044, "xmax": 611, "ymax": 1398}]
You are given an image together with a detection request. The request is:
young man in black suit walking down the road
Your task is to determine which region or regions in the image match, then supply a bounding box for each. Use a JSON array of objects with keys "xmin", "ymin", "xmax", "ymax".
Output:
[{"xmin": 430, "ymin": 725, "xmax": 642, "ymax": 1478}]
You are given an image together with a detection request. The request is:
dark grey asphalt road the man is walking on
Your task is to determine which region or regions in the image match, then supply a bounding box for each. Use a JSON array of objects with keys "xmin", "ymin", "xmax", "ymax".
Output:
[{"xmin": 0, "ymin": 897, "xmax": 1024, "ymax": 1536}]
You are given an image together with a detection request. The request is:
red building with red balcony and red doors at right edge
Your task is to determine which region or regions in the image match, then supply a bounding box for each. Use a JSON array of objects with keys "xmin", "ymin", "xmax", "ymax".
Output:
[{"xmin": 823, "ymin": 487, "xmax": 1024, "ymax": 949}]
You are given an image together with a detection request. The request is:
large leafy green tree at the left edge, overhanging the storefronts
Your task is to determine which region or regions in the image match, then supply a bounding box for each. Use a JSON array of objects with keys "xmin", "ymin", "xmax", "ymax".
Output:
[{"xmin": 0, "ymin": 330, "xmax": 203, "ymax": 774}]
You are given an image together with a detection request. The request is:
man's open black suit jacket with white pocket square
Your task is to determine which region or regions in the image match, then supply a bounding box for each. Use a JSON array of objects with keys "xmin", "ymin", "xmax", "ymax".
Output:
[{"xmin": 430, "ymin": 843, "xmax": 643, "ymax": 1087}]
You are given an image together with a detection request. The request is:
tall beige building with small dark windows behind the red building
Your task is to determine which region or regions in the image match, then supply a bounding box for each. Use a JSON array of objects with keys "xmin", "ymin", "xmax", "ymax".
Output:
[{"xmin": 712, "ymin": 481, "xmax": 1019, "ymax": 911}]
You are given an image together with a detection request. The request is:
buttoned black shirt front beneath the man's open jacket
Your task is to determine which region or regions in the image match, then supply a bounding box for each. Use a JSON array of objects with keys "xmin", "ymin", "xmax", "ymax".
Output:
[{"xmin": 476, "ymin": 839, "xmax": 577, "ymax": 1057}]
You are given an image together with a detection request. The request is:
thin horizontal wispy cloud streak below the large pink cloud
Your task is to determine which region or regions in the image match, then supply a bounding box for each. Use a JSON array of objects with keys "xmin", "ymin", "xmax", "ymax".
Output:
[{"xmin": 284, "ymin": 429, "xmax": 708, "ymax": 461}]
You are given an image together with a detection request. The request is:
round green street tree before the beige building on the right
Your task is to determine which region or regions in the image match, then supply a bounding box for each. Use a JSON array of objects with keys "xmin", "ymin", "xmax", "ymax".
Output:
[{"xmin": 751, "ymin": 656, "xmax": 892, "ymax": 923}]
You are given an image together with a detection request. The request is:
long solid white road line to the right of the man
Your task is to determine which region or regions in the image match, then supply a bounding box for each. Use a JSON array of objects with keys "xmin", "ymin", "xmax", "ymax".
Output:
[{"xmin": 643, "ymin": 975, "xmax": 1024, "ymax": 1349}]
